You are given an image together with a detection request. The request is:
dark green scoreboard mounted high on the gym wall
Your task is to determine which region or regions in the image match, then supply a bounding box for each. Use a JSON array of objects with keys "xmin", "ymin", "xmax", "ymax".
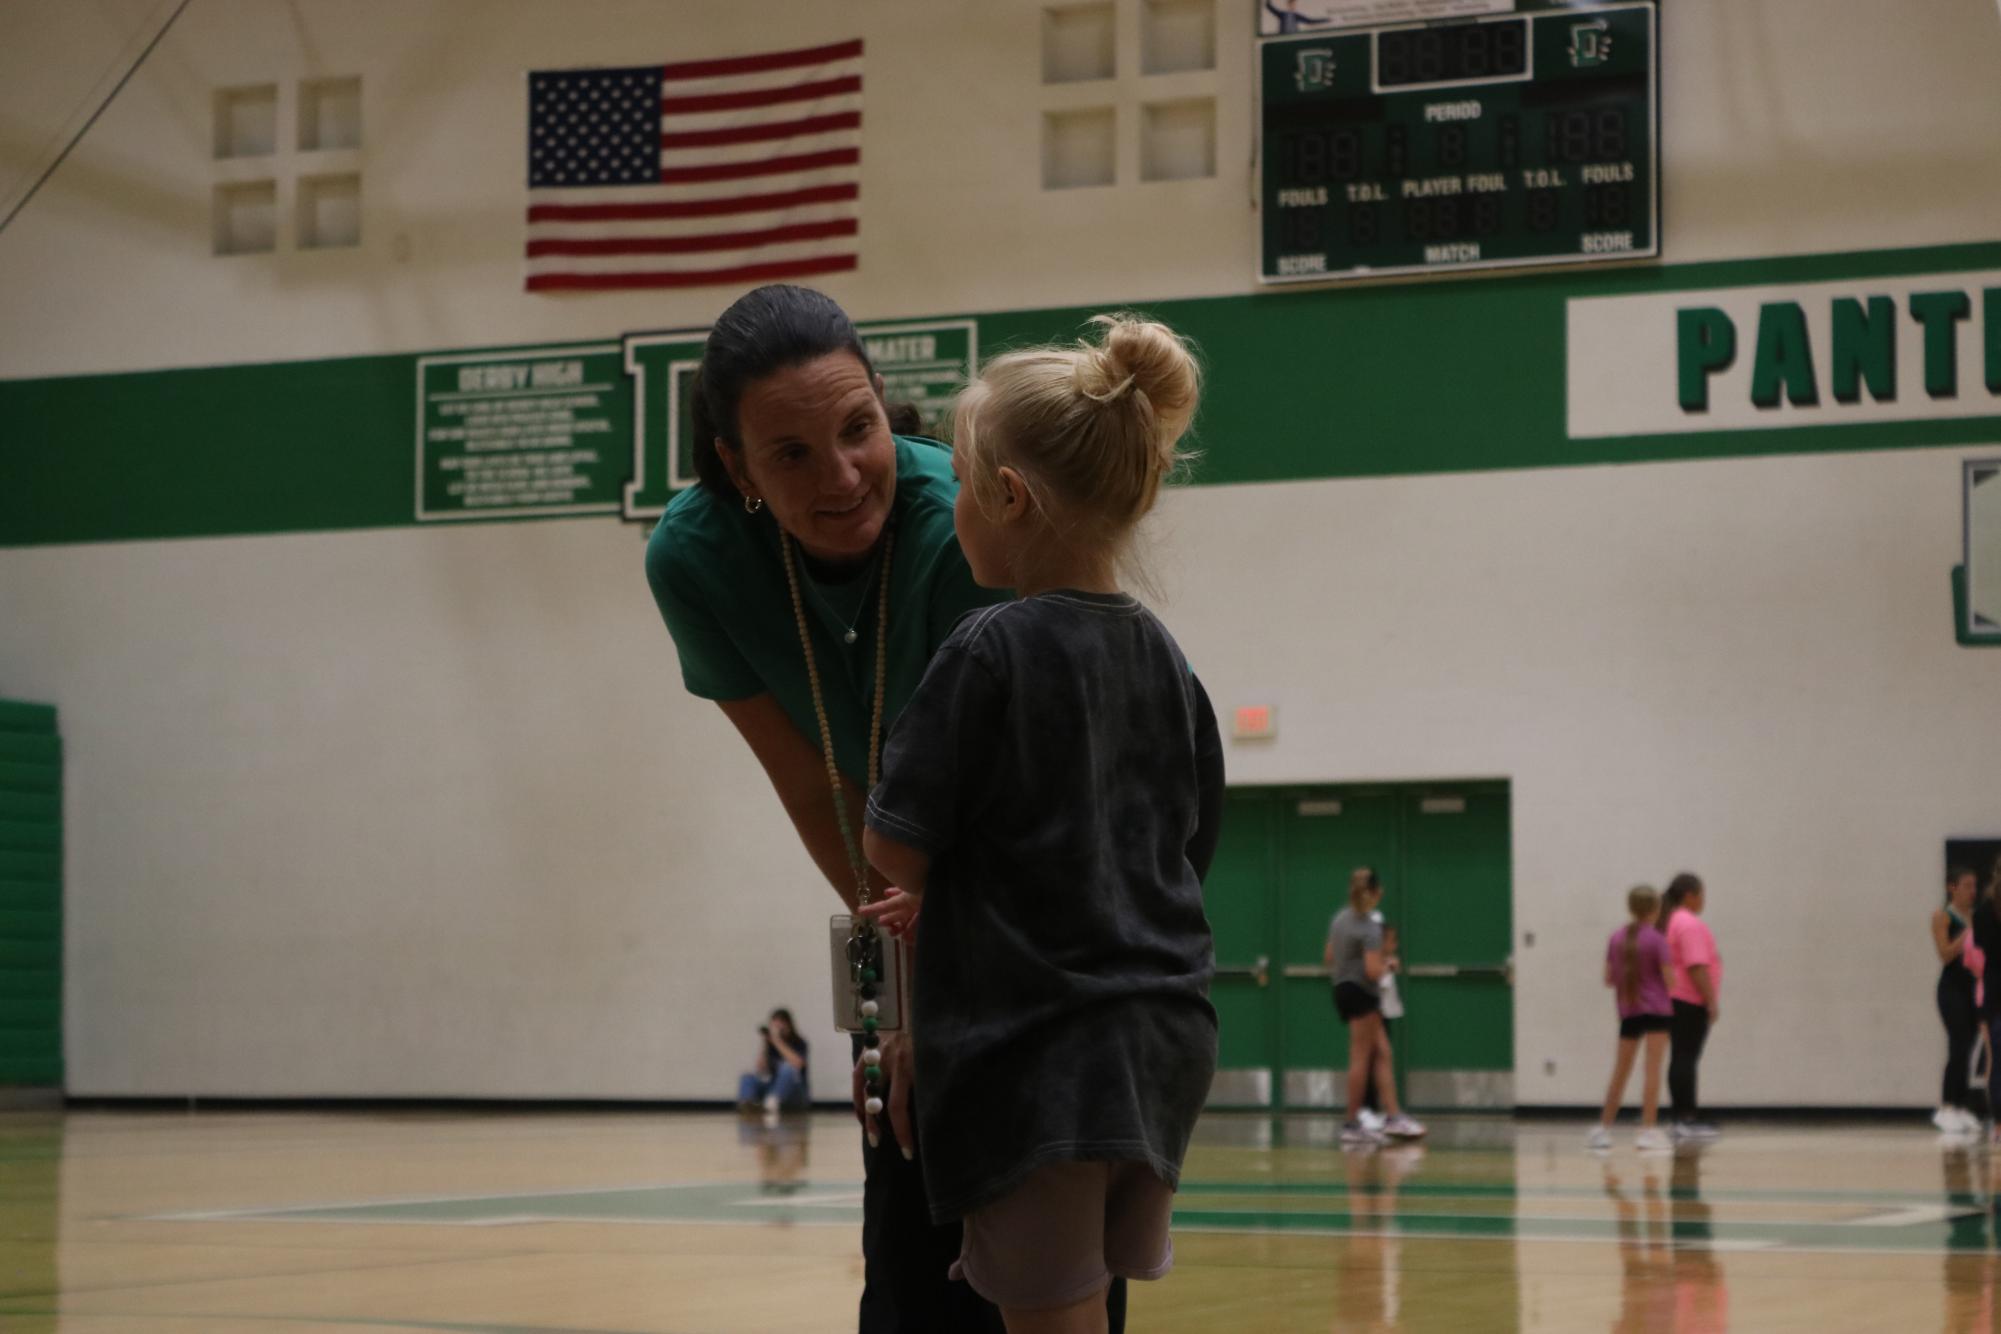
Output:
[{"xmin": 1259, "ymin": 0, "xmax": 1661, "ymax": 282}]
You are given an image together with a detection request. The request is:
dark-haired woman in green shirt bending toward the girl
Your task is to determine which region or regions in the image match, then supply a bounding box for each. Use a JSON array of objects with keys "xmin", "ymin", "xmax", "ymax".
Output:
[{"xmin": 646, "ymin": 284, "xmax": 1125, "ymax": 1334}]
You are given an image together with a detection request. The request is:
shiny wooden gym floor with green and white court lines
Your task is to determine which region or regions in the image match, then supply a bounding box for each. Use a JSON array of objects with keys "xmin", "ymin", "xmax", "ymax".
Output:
[{"xmin": 0, "ymin": 1112, "xmax": 2001, "ymax": 1334}]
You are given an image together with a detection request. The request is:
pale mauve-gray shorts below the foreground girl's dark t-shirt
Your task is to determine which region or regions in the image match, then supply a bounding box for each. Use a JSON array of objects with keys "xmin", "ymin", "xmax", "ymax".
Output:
[{"xmin": 952, "ymin": 1162, "xmax": 1175, "ymax": 1310}]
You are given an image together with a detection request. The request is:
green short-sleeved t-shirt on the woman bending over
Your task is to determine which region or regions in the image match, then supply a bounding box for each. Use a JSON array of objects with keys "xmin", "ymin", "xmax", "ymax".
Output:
[{"xmin": 646, "ymin": 436, "xmax": 1009, "ymax": 784}]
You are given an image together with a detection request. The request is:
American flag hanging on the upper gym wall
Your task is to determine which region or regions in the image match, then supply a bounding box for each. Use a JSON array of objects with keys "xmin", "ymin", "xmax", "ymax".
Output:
[{"xmin": 528, "ymin": 40, "xmax": 862, "ymax": 292}]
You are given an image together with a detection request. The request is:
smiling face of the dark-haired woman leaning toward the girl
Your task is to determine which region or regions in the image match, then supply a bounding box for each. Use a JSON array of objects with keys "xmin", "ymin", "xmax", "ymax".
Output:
[{"xmin": 718, "ymin": 352, "xmax": 896, "ymax": 560}]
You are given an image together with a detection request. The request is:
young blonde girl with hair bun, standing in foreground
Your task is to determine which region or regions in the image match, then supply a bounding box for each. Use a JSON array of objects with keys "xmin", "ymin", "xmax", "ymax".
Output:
[{"xmin": 864, "ymin": 316, "xmax": 1223, "ymax": 1334}]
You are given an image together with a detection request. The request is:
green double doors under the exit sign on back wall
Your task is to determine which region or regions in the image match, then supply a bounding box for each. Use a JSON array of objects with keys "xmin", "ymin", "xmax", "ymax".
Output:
[{"xmin": 1205, "ymin": 782, "xmax": 1515, "ymax": 1110}]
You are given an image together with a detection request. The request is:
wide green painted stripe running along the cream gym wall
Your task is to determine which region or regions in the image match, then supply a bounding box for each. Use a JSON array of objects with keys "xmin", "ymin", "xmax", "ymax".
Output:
[{"xmin": 11, "ymin": 242, "xmax": 2001, "ymax": 546}]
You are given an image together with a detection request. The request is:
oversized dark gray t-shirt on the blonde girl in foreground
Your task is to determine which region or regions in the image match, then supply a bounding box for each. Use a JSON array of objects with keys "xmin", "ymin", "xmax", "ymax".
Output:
[{"xmin": 868, "ymin": 592, "xmax": 1223, "ymax": 1222}]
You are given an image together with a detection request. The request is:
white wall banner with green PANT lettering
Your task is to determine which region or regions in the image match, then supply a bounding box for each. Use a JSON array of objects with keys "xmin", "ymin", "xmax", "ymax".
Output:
[{"xmin": 1567, "ymin": 270, "xmax": 2001, "ymax": 440}]
